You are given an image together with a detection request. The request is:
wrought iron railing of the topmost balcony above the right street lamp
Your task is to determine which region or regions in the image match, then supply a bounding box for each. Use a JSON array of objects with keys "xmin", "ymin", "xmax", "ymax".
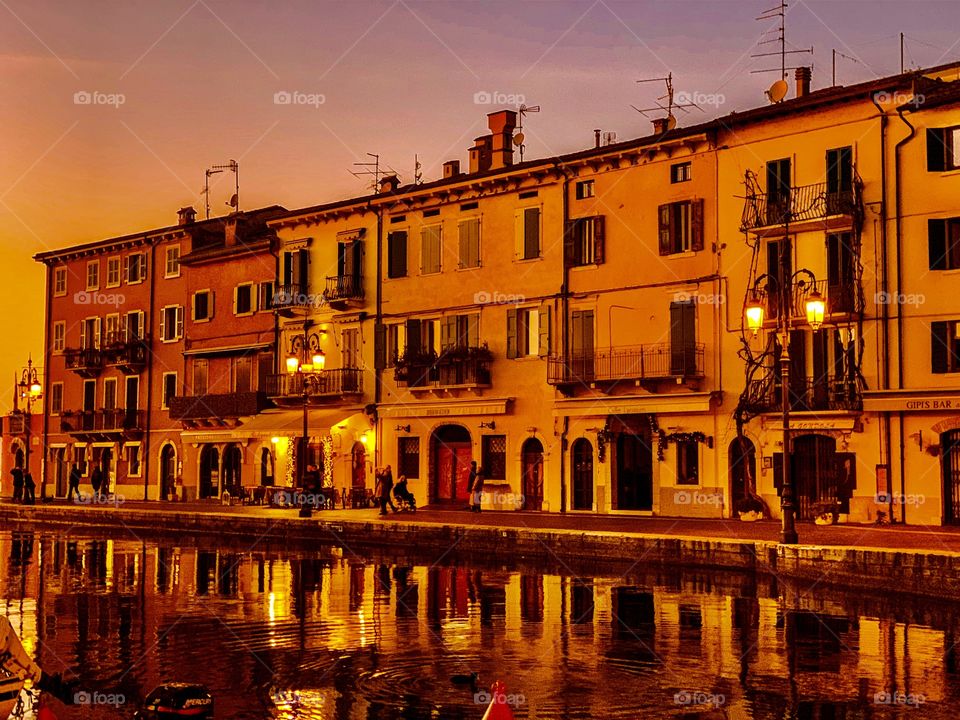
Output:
[{"xmin": 740, "ymin": 181, "xmax": 861, "ymax": 231}]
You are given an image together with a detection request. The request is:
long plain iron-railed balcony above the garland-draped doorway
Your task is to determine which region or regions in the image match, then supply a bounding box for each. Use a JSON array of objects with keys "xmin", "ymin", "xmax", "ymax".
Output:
[{"xmin": 547, "ymin": 343, "xmax": 704, "ymax": 386}]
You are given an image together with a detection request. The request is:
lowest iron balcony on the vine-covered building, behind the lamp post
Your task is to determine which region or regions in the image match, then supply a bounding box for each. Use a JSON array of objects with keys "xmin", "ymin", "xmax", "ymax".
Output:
[{"xmin": 742, "ymin": 372, "xmax": 863, "ymax": 414}]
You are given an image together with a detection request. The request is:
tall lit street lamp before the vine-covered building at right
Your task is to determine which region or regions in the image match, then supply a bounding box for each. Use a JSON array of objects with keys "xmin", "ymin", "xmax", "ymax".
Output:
[{"xmin": 744, "ymin": 256, "xmax": 827, "ymax": 545}]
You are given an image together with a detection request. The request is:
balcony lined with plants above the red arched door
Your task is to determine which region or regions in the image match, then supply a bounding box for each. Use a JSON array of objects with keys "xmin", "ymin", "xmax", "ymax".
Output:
[{"xmin": 393, "ymin": 345, "xmax": 493, "ymax": 393}]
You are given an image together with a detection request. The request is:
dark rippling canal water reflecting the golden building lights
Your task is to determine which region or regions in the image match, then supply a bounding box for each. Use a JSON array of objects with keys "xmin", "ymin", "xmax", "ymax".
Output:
[{"xmin": 0, "ymin": 530, "xmax": 960, "ymax": 720}]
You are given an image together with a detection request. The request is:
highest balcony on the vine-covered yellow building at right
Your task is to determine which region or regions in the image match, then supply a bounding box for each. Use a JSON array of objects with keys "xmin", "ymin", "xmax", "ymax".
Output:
[{"xmin": 740, "ymin": 178, "xmax": 863, "ymax": 235}]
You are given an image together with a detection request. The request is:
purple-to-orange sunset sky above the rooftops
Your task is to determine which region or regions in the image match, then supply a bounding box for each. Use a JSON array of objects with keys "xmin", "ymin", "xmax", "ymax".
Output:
[{"xmin": 0, "ymin": 0, "xmax": 960, "ymax": 408}]
